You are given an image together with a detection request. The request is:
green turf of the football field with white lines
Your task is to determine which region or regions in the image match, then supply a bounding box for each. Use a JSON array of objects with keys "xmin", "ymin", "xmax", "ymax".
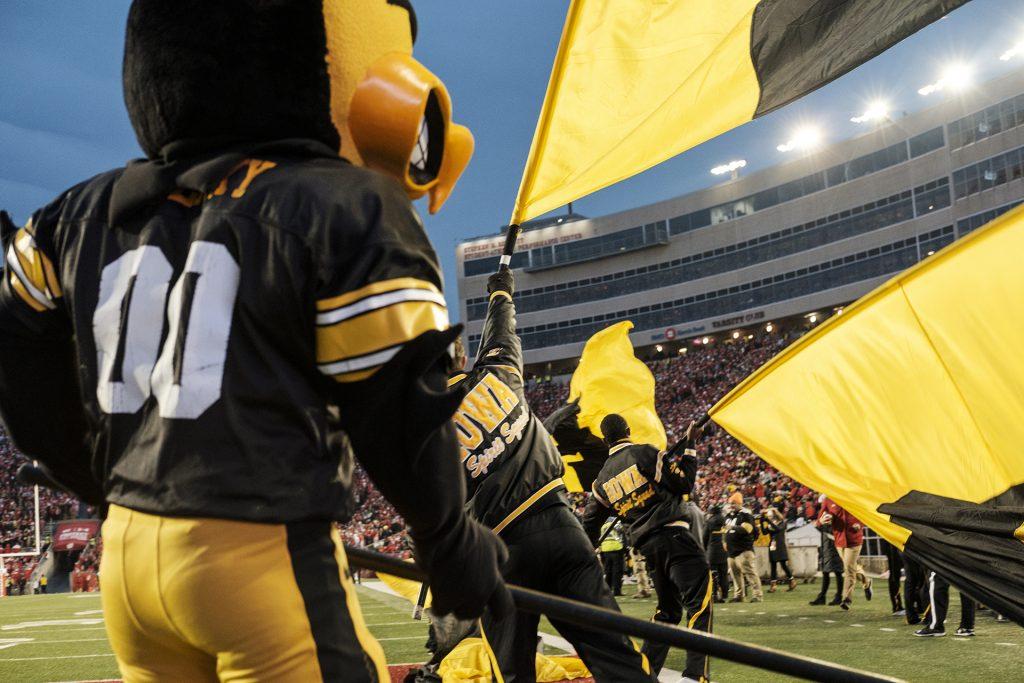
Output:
[{"xmin": 0, "ymin": 586, "xmax": 1024, "ymax": 683}]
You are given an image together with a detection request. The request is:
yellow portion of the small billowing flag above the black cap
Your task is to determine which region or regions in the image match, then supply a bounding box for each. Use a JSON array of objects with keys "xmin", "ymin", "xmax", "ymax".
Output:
[{"xmin": 569, "ymin": 321, "xmax": 667, "ymax": 450}]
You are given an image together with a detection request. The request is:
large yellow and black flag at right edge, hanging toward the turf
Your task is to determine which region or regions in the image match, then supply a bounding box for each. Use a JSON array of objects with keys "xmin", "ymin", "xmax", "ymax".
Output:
[{"xmin": 710, "ymin": 207, "xmax": 1024, "ymax": 625}]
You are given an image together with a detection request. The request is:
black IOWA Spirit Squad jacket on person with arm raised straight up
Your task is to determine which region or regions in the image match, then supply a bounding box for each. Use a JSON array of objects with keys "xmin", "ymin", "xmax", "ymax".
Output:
[{"xmin": 453, "ymin": 292, "xmax": 565, "ymax": 531}]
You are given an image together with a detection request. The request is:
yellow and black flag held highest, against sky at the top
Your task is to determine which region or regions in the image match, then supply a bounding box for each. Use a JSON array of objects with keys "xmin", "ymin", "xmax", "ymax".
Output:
[{"xmin": 512, "ymin": 0, "xmax": 968, "ymax": 223}]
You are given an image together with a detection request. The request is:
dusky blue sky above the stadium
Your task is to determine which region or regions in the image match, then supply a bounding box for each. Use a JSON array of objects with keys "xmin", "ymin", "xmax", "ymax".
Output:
[{"xmin": 0, "ymin": 0, "xmax": 1024, "ymax": 316}]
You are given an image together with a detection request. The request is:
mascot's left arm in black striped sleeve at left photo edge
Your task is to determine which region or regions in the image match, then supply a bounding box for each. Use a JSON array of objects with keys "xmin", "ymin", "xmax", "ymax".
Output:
[{"xmin": 0, "ymin": 207, "xmax": 103, "ymax": 505}]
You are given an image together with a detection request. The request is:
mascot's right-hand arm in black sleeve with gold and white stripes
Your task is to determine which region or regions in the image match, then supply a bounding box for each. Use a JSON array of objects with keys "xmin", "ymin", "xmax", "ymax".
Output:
[{"xmin": 314, "ymin": 179, "xmax": 465, "ymax": 547}]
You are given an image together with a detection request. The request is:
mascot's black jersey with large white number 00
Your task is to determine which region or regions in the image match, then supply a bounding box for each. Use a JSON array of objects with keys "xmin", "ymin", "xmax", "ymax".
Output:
[{"xmin": 0, "ymin": 139, "xmax": 447, "ymax": 523}]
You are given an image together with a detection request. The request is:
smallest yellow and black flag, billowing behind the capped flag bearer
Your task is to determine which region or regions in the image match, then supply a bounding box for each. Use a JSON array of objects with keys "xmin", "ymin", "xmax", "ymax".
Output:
[{"xmin": 546, "ymin": 321, "xmax": 667, "ymax": 490}]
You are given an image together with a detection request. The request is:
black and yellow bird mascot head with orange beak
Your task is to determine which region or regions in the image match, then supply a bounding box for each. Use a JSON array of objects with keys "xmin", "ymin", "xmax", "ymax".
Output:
[{"xmin": 124, "ymin": 0, "xmax": 473, "ymax": 213}]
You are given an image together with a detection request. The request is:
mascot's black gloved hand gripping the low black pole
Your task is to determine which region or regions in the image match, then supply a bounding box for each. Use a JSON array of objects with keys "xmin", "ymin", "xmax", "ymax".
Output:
[{"xmin": 414, "ymin": 517, "xmax": 515, "ymax": 618}]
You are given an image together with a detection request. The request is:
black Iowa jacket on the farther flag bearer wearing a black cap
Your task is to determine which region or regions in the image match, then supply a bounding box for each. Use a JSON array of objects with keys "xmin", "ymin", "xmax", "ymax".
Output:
[{"xmin": 583, "ymin": 442, "xmax": 699, "ymax": 546}]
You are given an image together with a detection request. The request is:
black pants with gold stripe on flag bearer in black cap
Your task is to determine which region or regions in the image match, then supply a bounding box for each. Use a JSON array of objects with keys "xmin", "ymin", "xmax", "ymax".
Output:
[{"xmin": 640, "ymin": 526, "xmax": 713, "ymax": 681}]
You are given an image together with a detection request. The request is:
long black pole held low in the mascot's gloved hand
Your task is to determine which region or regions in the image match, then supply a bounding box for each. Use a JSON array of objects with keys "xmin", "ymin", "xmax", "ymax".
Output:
[{"xmin": 345, "ymin": 546, "xmax": 899, "ymax": 683}]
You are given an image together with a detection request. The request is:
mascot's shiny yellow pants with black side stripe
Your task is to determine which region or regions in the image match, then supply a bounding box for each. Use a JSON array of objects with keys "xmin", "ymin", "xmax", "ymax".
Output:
[{"xmin": 99, "ymin": 506, "xmax": 390, "ymax": 683}]
